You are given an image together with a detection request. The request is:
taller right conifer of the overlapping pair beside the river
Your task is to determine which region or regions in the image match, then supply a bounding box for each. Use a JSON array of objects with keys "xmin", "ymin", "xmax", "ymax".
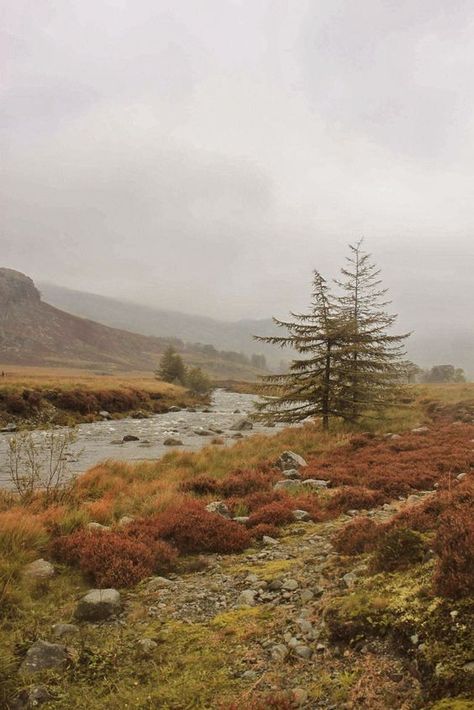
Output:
[{"xmin": 336, "ymin": 241, "xmax": 409, "ymax": 421}]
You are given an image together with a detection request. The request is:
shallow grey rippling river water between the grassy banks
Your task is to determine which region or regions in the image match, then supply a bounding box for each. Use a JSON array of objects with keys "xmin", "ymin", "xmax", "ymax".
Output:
[{"xmin": 0, "ymin": 389, "xmax": 281, "ymax": 488}]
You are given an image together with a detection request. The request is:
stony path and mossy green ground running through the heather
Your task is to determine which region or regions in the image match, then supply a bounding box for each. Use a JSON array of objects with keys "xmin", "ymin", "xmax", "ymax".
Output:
[{"xmin": 11, "ymin": 492, "xmax": 458, "ymax": 710}]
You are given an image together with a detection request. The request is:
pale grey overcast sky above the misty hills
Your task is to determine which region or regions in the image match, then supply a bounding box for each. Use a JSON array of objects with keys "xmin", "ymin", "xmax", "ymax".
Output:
[{"xmin": 0, "ymin": 0, "xmax": 474, "ymax": 327}]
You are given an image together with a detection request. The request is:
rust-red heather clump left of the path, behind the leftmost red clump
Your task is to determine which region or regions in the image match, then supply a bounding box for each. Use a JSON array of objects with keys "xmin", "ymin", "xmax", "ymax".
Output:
[{"xmin": 145, "ymin": 500, "xmax": 250, "ymax": 553}]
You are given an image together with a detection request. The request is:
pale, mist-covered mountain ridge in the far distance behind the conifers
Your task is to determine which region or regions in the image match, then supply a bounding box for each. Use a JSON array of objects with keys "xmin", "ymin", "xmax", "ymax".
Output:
[{"xmin": 41, "ymin": 283, "xmax": 474, "ymax": 379}]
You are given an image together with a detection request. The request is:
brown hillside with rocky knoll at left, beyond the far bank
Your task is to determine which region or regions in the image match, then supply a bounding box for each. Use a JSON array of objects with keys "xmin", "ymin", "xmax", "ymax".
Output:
[{"xmin": 0, "ymin": 268, "xmax": 260, "ymax": 378}]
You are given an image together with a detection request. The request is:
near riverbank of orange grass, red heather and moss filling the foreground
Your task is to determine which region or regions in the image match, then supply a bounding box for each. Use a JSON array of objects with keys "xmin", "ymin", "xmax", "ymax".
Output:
[{"xmin": 0, "ymin": 385, "xmax": 474, "ymax": 710}]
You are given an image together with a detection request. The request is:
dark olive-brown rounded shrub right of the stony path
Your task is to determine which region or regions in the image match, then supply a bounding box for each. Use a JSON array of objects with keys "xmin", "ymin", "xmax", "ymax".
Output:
[{"xmin": 372, "ymin": 528, "xmax": 426, "ymax": 572}]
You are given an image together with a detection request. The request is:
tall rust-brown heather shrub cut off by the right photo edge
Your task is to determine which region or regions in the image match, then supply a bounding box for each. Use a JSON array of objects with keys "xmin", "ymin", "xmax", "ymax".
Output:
[{"xmin": 434, "ymin": 506, "xmax": 474, "ymax": 598}]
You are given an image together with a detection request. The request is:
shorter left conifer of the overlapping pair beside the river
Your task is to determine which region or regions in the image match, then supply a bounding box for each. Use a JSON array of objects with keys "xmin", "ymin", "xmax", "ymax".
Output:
[{"xmin": 255, "ymin": 271, "xmax": 346, "ymax": 430}]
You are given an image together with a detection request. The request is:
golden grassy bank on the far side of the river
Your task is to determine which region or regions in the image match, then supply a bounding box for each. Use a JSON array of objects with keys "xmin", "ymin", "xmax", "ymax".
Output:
[{"xmin": 0, "ymin": 365, "xmax": 203, "ymax": 427}]
